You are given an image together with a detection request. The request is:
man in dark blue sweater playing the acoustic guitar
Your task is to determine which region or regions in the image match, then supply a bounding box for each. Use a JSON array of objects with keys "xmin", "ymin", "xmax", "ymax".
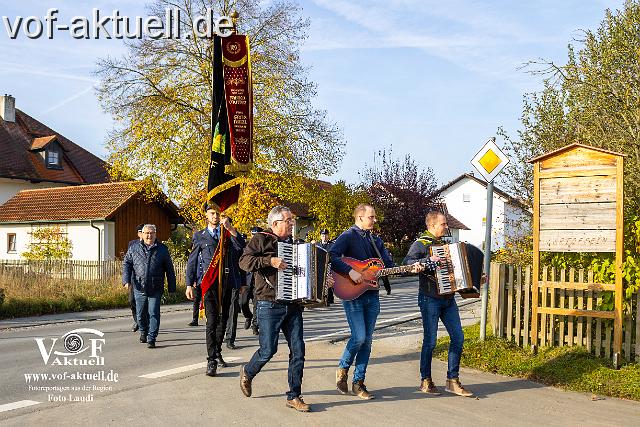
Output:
[{"xmin": 329, "ymin": 204, "xmax": 422, "ymax": 400}]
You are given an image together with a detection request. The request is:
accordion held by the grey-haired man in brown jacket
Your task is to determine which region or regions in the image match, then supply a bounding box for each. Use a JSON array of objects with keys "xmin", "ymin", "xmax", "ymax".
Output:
[{"xmin": 276, "ymin": 242, "xmax": 329, "ymax": 305}]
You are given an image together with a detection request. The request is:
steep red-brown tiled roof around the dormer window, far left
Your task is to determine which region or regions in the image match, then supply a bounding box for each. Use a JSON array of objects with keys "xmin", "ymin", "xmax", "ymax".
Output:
[{"xmin": 0, "ymin": 109, "xmax": 109, "ymax": 184}]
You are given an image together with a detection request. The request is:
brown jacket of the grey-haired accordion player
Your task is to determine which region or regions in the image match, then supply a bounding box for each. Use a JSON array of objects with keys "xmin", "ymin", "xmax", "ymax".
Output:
[{"xmin": 240, "ymin": 230, "xmax": 291, "ymax": 301}]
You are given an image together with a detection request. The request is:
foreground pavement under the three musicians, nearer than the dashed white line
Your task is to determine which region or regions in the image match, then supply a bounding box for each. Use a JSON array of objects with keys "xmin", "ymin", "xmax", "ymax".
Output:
[{"xmin": 3, "ymin": 300, "xmax": 640, "ymax": 427}]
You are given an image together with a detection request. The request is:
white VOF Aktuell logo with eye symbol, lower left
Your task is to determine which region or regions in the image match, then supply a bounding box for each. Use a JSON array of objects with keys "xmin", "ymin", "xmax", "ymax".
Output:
[{"xmin": 34, "ymin": 328, "xmax": 105, "ymax": 366}]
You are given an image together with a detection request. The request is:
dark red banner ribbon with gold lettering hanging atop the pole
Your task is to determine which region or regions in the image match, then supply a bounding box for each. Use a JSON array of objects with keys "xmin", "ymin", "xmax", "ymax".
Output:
[{"xmin": 222, "ymin": 34, "xmax": 253, "ymax": 175}]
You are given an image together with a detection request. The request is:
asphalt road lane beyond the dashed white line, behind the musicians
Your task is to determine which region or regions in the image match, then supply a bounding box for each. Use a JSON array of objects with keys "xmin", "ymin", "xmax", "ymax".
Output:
[{"xmin": 0, "ymin": 281, "xmax": 430, "ymax": 419}]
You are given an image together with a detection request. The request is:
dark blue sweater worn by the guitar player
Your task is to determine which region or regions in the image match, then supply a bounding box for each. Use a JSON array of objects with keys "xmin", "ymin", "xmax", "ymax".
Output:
[{"xmin": 329, "ymin": 225, "xmax": 394, "ymax": 274}]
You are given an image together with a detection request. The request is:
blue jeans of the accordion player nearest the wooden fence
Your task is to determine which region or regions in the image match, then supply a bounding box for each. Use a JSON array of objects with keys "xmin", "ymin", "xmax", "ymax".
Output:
[{"xmin": 418, "ymin": 292, "xmax": 464, "ymax": 379}]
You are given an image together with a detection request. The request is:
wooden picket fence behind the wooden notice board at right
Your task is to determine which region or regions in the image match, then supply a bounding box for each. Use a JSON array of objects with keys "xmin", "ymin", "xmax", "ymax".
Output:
[{"xmin": 489, "ymin": 263, "xmax": 640, "ymax": 362}]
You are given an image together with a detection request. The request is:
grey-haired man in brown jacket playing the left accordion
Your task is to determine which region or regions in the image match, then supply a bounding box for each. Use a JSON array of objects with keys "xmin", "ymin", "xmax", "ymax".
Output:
[{"xmin": 240, "ymin": 206, "xmax": 311, "ymax": 412}]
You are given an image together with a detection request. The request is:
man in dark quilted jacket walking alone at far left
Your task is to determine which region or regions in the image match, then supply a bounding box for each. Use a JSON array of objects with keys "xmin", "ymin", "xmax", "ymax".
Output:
[{"xmin": 122, "ymin": 224, "xmax": 176, "ymax": 348}]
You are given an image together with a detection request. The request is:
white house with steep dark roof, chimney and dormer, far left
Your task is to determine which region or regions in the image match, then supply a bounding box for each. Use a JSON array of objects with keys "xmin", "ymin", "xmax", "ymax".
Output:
[{"xmin": 0, "ymin": 95, "xmax": 109, "ymax": 204}]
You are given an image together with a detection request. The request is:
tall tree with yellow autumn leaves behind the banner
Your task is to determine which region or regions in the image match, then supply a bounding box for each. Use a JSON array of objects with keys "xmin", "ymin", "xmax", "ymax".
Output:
[{"xmin": 97, "ymin": 0, "xmax": 344, "ymax": 224}]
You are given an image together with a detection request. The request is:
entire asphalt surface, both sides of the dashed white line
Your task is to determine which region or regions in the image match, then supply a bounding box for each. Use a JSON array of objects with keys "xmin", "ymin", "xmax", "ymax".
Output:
[{"xmin": 0, "ymin": 282, "xmax": 640, "ymax": 427}]
